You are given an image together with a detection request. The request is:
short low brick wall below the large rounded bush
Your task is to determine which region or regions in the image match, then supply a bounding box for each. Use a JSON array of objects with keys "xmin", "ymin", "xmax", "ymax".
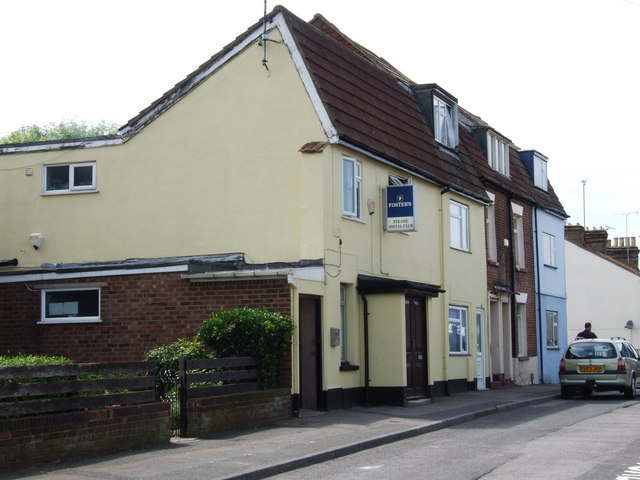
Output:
[{"xmin": 187, "ymin": 388, "xmax": 291, "ymax": 437}]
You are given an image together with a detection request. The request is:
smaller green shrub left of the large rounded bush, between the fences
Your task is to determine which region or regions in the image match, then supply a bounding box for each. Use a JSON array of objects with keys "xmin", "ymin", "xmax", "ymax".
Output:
[{"xmin": 145, "ymin": 338, "xmax": 209, "ymax": 401}]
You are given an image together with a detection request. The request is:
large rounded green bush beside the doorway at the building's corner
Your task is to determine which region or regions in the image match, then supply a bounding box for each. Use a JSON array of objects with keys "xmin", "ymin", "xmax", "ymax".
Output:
[{"xmin": 198, "ymin": 308, "xmax": 294, "ymax": 388}]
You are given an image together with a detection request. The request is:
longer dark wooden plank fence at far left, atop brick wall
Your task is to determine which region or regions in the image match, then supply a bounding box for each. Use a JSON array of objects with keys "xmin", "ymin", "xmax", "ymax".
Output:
[{"xmin": 0, "ymin": 362, "xmax": 156, "ymax": 417}]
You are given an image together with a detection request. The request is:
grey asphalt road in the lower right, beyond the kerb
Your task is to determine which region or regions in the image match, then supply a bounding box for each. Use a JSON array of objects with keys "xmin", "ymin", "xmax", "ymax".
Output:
[{"xmin": 274, "ymin": 394, "xmax": 640, "ymax": 480}]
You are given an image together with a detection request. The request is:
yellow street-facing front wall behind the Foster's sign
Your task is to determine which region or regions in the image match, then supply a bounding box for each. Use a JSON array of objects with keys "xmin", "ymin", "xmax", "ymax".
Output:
[{"xmin": 323, "ymin": 146, "xmax": 486, "ymax": 388}]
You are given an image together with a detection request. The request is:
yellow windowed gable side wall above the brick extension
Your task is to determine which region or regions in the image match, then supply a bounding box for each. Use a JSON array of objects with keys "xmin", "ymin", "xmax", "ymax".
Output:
[{"xmin": 0, "ymin": 28, "xmax": 325, "ymax": 268}]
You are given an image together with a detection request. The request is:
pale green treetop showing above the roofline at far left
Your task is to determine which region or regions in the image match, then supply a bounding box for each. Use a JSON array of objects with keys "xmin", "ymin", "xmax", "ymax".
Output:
[{"xmin": 0, "ymin": 120, "xmax": 118, "ymax": 144}]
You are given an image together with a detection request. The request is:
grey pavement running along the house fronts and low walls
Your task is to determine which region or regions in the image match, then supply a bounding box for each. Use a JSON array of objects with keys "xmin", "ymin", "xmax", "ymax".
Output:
[{"xmin": 5, "ymin": 384, "xmax": 560, "ymax": 480}]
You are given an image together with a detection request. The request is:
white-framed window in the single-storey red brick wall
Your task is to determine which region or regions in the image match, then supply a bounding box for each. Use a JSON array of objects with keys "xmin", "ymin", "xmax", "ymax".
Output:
[{"xmin": 41, "ymin": 288, "xmax": 100, "ymax": 323}]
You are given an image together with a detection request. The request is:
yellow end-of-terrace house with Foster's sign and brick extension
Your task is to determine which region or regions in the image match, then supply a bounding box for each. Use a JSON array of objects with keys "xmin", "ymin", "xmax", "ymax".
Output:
[{"xmin": 0, "ymin": 7, "xmax": 564, "ymax": 409}]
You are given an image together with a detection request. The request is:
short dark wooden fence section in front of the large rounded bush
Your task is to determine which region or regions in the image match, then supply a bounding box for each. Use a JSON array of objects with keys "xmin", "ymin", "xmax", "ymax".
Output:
[{"xmin": 180, "ymin": 357, "xmax": 260, "ymax": 437}]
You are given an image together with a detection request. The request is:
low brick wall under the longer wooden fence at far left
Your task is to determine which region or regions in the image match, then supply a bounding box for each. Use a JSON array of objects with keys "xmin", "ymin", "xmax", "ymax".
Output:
[{"xmin": 0, "ymin": 402, "xmax": 171, "ymax": 471}]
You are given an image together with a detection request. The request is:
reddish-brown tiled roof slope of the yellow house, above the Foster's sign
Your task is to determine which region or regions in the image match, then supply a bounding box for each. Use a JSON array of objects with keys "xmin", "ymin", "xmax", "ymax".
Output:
[{"xmin": 281, "ymin": 9, "xmax": 487, "ymax": 200}]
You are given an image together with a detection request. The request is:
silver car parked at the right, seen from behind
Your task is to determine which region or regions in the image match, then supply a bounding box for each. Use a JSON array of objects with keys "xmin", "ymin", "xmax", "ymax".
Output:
[{"xmin": 560, "ymin": 337, "xmax": 640, "ymax": 399}]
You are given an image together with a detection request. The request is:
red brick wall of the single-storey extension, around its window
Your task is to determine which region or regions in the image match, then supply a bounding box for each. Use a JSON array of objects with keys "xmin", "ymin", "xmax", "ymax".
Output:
[{"xmin": 0, "ymin": 273, "xmax": 291, "ymax": 362}]
